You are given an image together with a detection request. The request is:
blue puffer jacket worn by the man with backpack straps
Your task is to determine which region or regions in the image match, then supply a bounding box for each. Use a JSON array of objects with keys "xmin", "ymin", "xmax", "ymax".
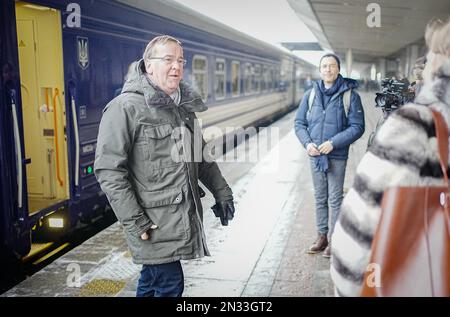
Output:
[{"xmin": 295, "ymin": 75, "xmax": 364, "ymax": 160}]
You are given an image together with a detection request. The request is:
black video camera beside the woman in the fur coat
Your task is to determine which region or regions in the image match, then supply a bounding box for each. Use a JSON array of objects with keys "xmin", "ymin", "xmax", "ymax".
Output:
[{"xmin": 375, "ymin": 78, "xmax": 415, "ymax": 116}]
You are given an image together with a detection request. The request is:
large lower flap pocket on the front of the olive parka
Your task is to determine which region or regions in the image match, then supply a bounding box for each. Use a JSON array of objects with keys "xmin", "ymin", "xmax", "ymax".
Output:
[{"xmin": 138, "ymin": 189, "xmax": 187, "ymax": 243}]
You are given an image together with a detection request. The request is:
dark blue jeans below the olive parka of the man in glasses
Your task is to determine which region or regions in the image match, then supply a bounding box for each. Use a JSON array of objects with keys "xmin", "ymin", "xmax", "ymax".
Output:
[{"xmin": 136, "ymin": 261, "xmax": 184, "ymax": 297}]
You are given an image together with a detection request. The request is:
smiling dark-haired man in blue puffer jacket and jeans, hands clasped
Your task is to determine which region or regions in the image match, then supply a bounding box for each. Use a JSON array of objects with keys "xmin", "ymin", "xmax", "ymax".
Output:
[{"xmin": 295, "ymin": 54, "xmax": 364, "ymax": 258}]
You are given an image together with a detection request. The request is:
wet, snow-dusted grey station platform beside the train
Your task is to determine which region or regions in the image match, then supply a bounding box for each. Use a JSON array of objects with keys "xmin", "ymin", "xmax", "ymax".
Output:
[{"xmin": 2, "ymin": 92, "xmax": 381, "ymax": 297}]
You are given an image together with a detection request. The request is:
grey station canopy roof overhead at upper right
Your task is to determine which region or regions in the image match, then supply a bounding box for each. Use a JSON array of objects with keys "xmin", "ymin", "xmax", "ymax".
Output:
[{"xmin": 287, "ymin": 0, "xmax": 450, "ymax": 62}]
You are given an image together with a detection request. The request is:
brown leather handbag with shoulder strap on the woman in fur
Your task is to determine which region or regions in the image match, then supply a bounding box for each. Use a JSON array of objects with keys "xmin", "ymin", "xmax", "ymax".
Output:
[{"xmin": 361, "ymin": 110, "xmax": 450, "ymax": 296}]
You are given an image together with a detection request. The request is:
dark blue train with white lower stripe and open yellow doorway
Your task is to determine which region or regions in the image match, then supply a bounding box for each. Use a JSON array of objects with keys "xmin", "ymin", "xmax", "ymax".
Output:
[{"xmin": 0, "ymin": 0, "xmax": 314, "ymax": 286}]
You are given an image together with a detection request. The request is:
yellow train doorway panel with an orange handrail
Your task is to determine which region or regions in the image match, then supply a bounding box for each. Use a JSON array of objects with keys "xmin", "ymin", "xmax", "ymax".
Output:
[{"xmin": 16, "ymin": 2, "xmax": 69, "ymax": 214}]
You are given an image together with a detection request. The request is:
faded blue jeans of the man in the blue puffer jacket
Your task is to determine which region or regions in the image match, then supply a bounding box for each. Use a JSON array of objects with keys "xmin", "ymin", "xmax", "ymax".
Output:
[{"xmin": 310, "ymin": 158, "xmax": 347, "ymax": 237}]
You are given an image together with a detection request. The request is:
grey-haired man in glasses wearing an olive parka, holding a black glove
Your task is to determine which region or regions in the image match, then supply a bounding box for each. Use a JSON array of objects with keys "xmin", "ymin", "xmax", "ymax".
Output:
[{"xmin": 94, "ymin": 36, "xmax": 234, "ymax": 296}]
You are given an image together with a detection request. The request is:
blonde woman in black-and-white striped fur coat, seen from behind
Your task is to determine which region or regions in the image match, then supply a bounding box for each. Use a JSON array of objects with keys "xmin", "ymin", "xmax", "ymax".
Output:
[{"xmin": 330, "ymin": 19, "xmax": 450, "ymax": 296}]
